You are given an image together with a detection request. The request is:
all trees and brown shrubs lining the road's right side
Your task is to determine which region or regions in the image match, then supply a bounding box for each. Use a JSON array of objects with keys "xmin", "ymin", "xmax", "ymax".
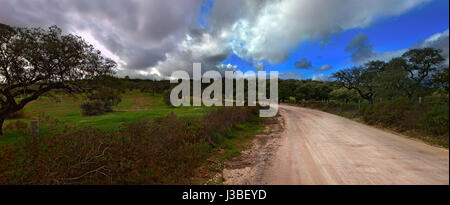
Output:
[{"xmin": 279, "ymin": 48, "xmax": 449, "ymax": 148}]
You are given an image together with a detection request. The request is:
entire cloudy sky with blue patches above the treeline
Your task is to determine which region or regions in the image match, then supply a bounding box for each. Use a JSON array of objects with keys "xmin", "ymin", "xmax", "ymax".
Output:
[{"xmin": 0, "ymin": 0, "xmax": 449, "ymax": 80}]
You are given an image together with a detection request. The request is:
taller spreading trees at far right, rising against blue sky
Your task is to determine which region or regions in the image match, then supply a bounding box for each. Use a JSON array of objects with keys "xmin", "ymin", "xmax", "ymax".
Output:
[{"xmin": 333, "ymin": 48, "xmax": 449, "ymax": 104}]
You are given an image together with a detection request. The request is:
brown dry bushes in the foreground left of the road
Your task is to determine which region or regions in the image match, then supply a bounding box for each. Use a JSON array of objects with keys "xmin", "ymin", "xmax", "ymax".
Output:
[{"xmin": 0, "ymin": 105, "xmax": 257, "ymax": 184}]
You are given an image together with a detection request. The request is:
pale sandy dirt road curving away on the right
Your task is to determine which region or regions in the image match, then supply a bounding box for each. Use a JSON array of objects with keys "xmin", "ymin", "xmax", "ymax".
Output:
[{"xmin": 254, "ymin": 105, "xmax": 449, "ymax": 184}]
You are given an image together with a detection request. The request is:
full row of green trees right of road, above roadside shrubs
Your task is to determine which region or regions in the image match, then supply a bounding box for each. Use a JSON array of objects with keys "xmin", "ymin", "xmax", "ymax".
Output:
[{"xmin": 279, "ymin": 48, "xmax": 449, "ymax": 104}]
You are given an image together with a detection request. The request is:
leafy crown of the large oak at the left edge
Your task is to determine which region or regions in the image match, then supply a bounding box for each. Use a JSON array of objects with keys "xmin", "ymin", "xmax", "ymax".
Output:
[{"xmin": 0, "ymin": 24, "xmax": 116, "ymax": 136}]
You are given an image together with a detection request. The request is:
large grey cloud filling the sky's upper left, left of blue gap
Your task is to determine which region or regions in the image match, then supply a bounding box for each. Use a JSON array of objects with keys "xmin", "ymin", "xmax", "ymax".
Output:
[{"xmin": 0, "ymin": 0, "xmax": 201, "ymax": 70}]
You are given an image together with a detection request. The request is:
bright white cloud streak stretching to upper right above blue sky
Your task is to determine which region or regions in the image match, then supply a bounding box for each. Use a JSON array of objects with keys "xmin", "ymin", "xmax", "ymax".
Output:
[{"xmin": 221, "ymin": 0, "xmax": 429, "ymax": 64}]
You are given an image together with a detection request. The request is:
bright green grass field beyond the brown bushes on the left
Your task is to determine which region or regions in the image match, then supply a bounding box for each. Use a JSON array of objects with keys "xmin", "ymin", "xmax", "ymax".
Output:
[{"xmin": 0, "ymin": 90, "xmax": 212, "ymax": 144}]
